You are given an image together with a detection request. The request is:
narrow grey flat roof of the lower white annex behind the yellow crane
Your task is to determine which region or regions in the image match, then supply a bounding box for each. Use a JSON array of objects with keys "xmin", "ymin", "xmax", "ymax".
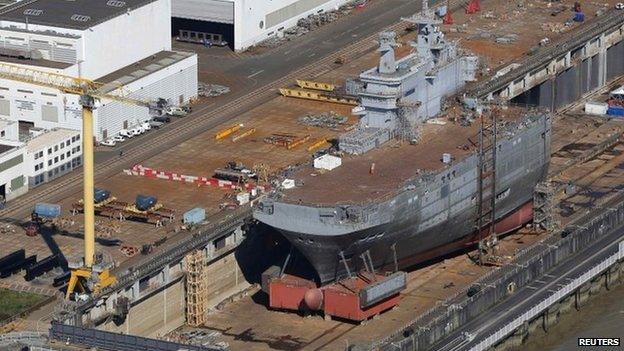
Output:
[{"xmin": 96, "ymin": 51, "xmax": 195, "ymax": 93}]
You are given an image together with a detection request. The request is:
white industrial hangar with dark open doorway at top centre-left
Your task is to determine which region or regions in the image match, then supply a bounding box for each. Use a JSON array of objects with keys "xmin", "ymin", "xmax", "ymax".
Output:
[{"xmin": 171, "ymin": 0, "xmax": 350, "ymax": 51}]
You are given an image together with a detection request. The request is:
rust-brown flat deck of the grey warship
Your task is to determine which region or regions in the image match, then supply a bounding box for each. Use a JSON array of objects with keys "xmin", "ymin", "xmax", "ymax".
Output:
[{"xmin": 282, "ymin": 107, "xmax": 527, "ymax": 206}]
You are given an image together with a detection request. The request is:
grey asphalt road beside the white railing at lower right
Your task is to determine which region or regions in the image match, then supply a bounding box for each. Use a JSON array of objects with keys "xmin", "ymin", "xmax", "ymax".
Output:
[{"xmin": 432, "ymin": 227, "xmax": 624, "ymax": 351}]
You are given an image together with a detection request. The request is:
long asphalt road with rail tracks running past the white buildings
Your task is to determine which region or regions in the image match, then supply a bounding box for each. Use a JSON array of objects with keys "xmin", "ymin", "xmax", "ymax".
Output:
[{"xmin": 0, "ymin": 0, "xmax": 434, "ymax": 221}]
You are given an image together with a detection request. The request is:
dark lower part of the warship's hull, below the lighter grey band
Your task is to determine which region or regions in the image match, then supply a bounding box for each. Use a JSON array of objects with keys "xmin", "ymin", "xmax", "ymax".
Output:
[{"xmin": 277, "ymin": 165, "xmax": 548, "ymax": 284}]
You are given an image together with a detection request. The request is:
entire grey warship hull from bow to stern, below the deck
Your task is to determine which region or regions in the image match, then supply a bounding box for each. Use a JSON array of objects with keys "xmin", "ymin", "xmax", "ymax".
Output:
[{"xmin": 255, "ymin": 115, "xmax": 550, "ymax": 283}]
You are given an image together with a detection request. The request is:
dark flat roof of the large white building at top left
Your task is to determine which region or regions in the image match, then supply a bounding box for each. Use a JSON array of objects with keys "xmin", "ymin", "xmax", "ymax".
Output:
[{"xmin": 0, "ymin": 0, "xmax": 156, "ymax": 30}]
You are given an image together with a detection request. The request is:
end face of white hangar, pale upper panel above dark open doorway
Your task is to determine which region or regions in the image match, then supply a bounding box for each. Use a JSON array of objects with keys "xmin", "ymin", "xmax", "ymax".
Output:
[{"xmin": 171, "ymin": 0, "xmax": 234, "ymax": 48}]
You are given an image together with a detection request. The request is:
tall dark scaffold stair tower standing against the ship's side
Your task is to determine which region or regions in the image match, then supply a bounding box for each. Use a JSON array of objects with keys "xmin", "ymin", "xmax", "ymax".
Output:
[{"xmin": 475, "ymin": 108, "xmax": 500, "ymax": 264}]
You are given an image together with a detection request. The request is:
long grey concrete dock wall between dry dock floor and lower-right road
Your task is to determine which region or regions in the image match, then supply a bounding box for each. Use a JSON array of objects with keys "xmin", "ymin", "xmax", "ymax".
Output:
[{"xmin": 364, "ymin": 198, "xmax": 624, "ymax": 351}]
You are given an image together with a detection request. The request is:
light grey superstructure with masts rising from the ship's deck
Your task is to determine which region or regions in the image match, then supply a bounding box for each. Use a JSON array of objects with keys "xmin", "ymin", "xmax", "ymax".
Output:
[{"xmin": 340, "ymin": 2, "xmax": 478, "ymax": 154}]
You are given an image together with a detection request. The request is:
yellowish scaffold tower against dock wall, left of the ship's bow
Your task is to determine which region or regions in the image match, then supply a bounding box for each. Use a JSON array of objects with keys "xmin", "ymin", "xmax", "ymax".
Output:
[{"xmin": 184, "ymin": 250, "xmax": 208, "ymax": 327}]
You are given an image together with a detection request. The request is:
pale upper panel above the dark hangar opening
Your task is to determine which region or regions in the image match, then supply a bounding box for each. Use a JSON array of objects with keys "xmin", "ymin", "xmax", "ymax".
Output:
[{"xmin": 171, "ymin": 0, "xmax": 234, "ymax": 24}]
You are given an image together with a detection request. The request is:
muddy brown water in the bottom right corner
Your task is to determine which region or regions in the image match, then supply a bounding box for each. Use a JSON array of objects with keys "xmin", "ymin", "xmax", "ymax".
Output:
[{"xmin": 521, "ymin": 284, "xmax": 624, "ymax": 351}]
